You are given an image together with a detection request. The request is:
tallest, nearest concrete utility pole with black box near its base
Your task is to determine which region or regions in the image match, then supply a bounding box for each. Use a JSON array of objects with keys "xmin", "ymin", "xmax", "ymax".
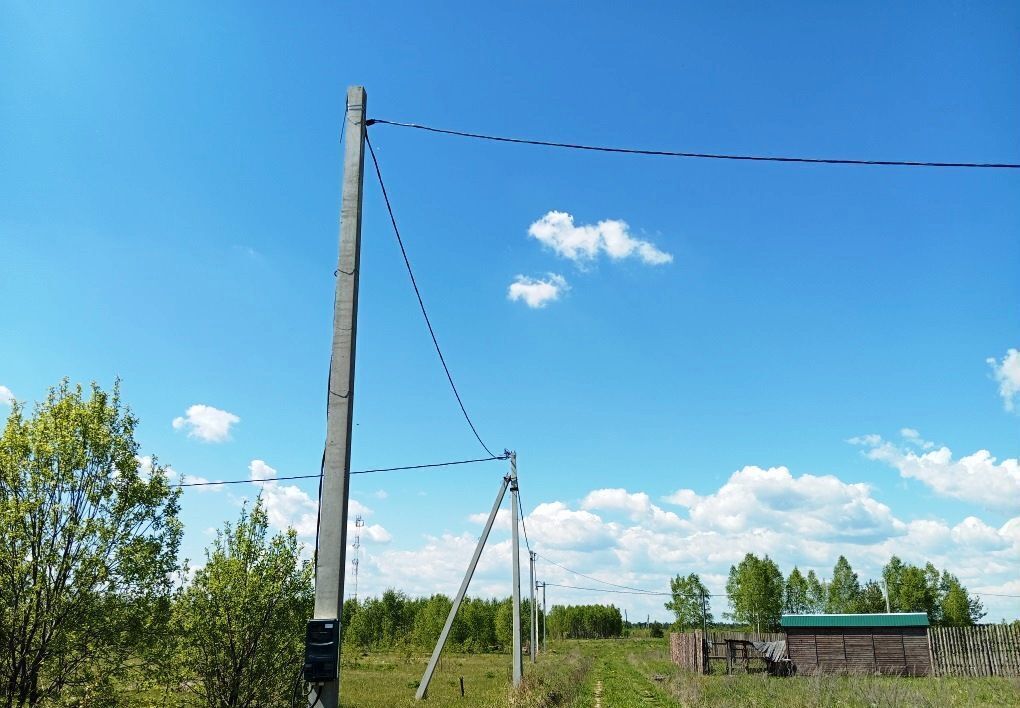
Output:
[{"xmin": 310, "ymin": 86, "xmax": 367, "ymax": 708}]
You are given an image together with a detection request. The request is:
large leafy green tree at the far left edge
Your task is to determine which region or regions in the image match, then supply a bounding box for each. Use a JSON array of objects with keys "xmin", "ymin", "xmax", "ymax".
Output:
[{"xmin": 0, "ymin": 380, "xmax": 181, "ymax": 708}]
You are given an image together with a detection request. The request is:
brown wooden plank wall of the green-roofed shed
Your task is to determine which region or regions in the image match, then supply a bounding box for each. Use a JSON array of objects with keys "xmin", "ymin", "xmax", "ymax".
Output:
[{"xmin": 786, "ymin": 626, "xmax": 931, "ymax": 676}]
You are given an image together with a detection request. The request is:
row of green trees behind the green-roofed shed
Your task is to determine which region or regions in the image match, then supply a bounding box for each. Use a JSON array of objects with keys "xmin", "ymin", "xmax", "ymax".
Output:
[{"xmin": 666, "ymin": 553, "xmax": 985, "ymax": 631}]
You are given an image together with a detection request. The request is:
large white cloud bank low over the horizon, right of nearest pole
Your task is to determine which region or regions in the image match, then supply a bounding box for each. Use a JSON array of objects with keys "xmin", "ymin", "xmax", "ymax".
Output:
[{"xmin": 344, "ymin": 457, "xmax": 1020, "ymax": 621}]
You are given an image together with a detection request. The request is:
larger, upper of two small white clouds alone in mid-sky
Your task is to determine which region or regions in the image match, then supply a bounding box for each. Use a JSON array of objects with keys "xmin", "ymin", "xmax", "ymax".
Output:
[{"xmin": 527, "ymin": 211, "xmax": 673, "ymax": 265}]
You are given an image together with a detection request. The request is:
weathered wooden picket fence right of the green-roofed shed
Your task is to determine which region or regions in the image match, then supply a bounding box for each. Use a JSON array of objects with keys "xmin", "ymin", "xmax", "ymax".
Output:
[{"xmin": 928, "ymin": 624, "xmax": 1020, "ymax": 676}]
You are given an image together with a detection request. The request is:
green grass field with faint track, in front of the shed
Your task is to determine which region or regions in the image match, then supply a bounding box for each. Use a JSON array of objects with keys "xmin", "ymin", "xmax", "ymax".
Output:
[{"xmin": 334, "ymin": 640, "xmax": 1020, "ymax": 708}]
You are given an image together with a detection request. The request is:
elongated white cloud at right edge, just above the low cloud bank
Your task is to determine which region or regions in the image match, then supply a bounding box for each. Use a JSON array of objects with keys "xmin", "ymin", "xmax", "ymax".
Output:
[{"xmin": 850, "ymin": 436, "xmax": 1020, "ymax": 513}]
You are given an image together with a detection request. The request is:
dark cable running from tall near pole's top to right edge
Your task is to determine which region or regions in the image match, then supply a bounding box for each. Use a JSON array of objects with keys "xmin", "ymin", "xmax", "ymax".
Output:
[{"xmin": 366, "ymin": 118, "xmax": 1020, "ymax": 169}]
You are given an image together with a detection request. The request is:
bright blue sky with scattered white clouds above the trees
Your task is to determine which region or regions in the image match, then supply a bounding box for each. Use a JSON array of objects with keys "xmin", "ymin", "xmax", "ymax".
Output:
[{"xmin": 0, "ymin": 2, "xmax": 1020, "ymax": 619}]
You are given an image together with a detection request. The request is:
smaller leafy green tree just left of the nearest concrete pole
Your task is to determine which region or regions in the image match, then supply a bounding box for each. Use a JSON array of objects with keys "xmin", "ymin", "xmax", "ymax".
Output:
[{"xmin": 169, "ymin": 498, "xmax": 312, "ymax": 708}]
